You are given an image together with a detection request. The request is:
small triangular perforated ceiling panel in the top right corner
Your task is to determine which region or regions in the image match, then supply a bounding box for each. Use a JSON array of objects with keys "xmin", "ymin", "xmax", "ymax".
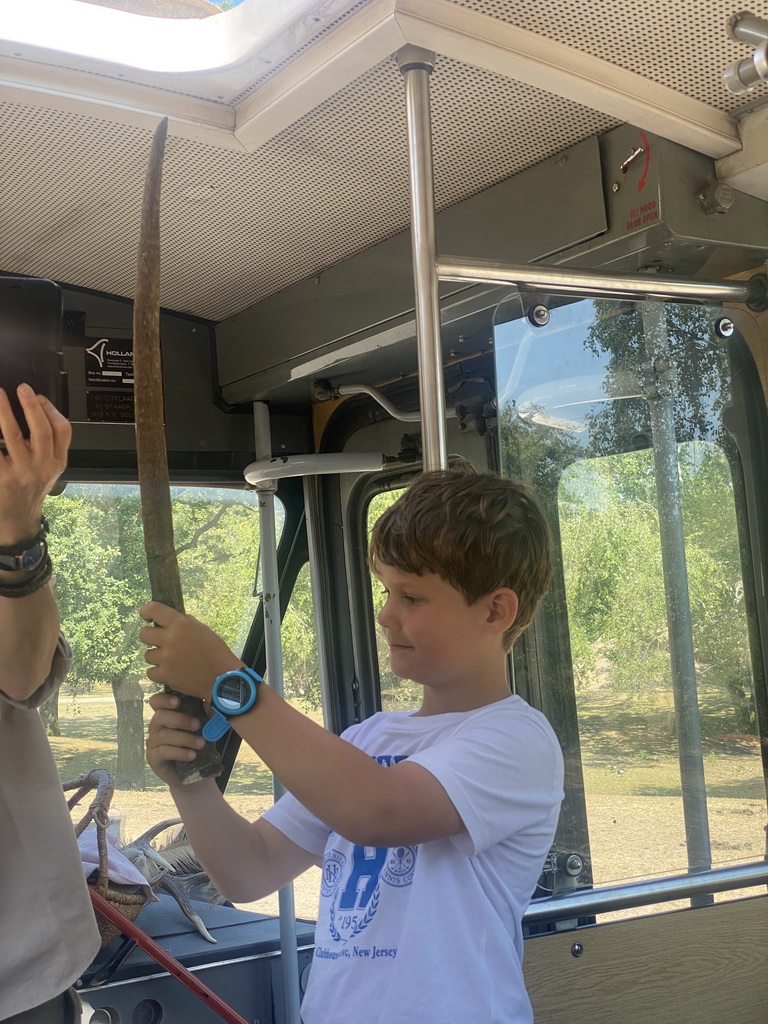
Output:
[{"xmin": 452, "ymin": 0, "xmax": 768, "ymax": 111}]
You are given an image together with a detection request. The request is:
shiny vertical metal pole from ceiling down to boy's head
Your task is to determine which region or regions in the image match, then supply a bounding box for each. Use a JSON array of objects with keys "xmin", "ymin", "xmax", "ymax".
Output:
[{"xmin": 397, "ymin": 46, "xmax": 447, "ymax": 469}]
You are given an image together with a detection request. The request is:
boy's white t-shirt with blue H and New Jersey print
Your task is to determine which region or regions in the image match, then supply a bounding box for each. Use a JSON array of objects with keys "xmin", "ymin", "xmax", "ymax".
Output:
[{"xmin": 264, "ymin": 696, "xmax": 563, "ymax": 1024}]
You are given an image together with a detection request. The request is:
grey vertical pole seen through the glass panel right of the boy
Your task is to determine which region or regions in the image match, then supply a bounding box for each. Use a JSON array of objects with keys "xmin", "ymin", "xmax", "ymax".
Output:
[{"xmin": 643, "ymin": 302, "xmax": 713, "ymax": 906}]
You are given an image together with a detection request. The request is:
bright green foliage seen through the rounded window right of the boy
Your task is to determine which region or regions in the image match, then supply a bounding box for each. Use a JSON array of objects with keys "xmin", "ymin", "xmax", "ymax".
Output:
[{"xmin": 559, "ymin": 442, "xmax": 752, "ymax": 728}]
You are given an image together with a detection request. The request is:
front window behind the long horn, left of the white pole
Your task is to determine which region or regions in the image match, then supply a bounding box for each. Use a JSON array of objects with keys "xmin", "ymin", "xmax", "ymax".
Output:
[{"xmin": 42, "ymin": 483, "xmax": 270, "ymax": 840}]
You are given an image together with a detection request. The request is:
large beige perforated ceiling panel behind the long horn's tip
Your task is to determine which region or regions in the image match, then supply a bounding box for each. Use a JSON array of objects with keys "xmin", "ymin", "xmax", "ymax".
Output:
[{"xmin": 0, "ymin": 58, "xmax": 613, "ymax": 321}]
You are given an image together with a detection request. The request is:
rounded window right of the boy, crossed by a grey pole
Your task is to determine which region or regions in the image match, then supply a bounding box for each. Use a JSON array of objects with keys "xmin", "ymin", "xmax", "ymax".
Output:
[{"xmin": 558, "ymin": 441, "xmax": 765, "ymax": 884}]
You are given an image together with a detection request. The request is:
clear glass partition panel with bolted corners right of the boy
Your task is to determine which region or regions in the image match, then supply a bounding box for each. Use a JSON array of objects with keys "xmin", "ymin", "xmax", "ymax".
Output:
[{"xmin": 495, "ymin": 296, "xmax": 766, "ymax": 899}]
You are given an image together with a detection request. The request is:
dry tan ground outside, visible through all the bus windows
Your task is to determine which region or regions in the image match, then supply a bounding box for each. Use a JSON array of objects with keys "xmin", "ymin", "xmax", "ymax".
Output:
[{"xmin": 57, "ymin": 686, "xmax": 767, "ymax": 920}]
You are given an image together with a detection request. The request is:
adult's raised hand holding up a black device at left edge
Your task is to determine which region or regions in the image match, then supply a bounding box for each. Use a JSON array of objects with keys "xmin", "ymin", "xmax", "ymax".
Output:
[{"xmin": 0, "ymin": 384, "xmax": 72, "ymax": 546}]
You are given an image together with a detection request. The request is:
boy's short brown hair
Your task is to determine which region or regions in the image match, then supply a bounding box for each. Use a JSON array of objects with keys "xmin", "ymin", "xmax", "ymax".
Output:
[{"xmin": 369, "ymin": 467, "xmax": 552, "ymax": 650}]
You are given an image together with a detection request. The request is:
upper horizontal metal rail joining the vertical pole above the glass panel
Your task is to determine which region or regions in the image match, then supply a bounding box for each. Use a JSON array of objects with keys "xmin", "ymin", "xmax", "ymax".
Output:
[{"xmin": 437, "ymin": 256, "xmax": 767, "ymax": 310}]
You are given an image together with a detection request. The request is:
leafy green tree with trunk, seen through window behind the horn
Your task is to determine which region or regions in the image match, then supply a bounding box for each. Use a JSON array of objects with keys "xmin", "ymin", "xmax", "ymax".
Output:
[{"xmin": 46, "ymin": 485, "xmax": 258, "ymax": 788}]
